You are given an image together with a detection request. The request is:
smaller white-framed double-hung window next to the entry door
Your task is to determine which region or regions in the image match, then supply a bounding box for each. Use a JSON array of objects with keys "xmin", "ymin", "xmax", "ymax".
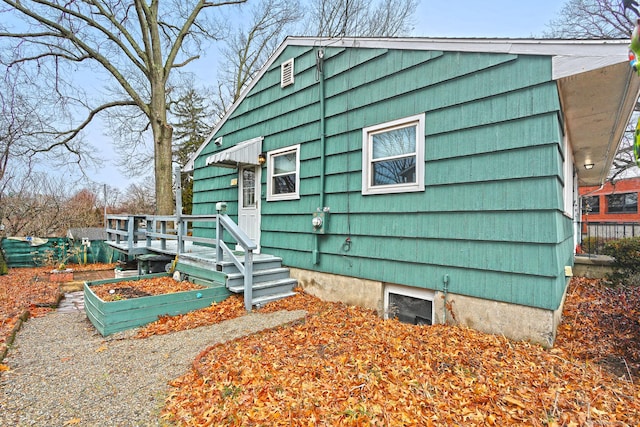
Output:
[{"xmin": 267, "ymin": 144, "xmax": 300, "ymax": 200}]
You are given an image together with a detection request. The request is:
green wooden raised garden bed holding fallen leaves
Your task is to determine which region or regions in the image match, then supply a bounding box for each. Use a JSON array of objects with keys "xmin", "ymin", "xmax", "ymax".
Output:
[{"xmin": 84, "ymin": 273, "xmax": 230, "ymax": 336}]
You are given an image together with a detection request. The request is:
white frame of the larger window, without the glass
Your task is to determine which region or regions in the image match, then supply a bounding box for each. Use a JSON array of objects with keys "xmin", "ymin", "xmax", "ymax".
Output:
[{"xmin": 362, "ymin": 114, "xmax": 425, "ymax": 195}]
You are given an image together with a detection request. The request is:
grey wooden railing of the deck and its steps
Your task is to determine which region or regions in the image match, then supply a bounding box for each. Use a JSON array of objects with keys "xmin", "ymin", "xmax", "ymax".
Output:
[{"xmin": 106, "ymin": 213, "xmax": 257, "ymax": 311}]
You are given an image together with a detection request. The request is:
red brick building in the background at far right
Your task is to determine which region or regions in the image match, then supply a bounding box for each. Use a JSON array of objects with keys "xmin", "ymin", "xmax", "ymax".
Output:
[{"xmin": 579, "ymin": 177, "xmax": 640, "ymax": 224}]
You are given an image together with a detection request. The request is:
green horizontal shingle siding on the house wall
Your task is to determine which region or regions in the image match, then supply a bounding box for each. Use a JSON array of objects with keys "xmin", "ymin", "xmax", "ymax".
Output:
[{"xmin": 193, "ymin": 46, "xmax": 573, "ymax": 309}]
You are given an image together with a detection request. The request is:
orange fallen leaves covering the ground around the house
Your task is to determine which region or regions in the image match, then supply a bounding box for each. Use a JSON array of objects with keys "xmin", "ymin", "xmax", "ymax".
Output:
[{"xmin": 0, "ymin": 269, "xmax": 640, "ymax": 426}]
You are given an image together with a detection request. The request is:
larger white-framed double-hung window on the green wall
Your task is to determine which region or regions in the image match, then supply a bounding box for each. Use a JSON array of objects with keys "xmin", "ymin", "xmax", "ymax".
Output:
[{"xmin": 362, "ymin": 114, "xmax": 424, "ymax": 194}]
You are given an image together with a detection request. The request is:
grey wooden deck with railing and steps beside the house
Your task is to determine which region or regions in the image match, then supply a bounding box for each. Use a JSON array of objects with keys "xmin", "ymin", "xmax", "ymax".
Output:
[{"xmin": 105, "ymin": 214, "xmax": 297, "ymax": 311}]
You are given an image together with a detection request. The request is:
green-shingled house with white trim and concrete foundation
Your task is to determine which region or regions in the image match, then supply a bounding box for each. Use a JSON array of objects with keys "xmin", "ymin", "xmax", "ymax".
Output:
[{"xmin": 184, "ymin": 38, "xmax": 639, "ymax": 346}]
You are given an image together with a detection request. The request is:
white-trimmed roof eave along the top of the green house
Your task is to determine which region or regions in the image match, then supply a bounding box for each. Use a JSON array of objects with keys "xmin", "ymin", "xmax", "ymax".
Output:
[{"xmin": 183, "ymin": 37, "xmax": 639, "ymax": 185}]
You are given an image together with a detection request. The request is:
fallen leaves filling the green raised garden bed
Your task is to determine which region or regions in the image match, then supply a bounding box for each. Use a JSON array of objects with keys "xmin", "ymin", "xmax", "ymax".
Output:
[{"xmin": 91, "ymin": 276, "xmax": 204, "ymax": 301}]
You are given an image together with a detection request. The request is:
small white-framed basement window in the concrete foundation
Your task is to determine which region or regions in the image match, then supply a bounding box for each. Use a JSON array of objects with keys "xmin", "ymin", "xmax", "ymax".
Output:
[{"xmin": 384, "ymin": 285, "xmax": 435, "ymax": 325}]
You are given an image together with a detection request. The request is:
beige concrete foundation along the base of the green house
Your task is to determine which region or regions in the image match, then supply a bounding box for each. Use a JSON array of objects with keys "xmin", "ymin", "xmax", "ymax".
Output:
[{"xmin": 291, "ymin": 268, "xmax": 566, "ymax": 348}]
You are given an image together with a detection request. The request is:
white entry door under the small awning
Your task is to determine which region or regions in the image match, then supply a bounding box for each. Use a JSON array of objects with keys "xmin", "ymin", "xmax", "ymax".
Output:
[{"xmin": 237, "ymin": 166, "xmax": 261, "ymax": 253}]
